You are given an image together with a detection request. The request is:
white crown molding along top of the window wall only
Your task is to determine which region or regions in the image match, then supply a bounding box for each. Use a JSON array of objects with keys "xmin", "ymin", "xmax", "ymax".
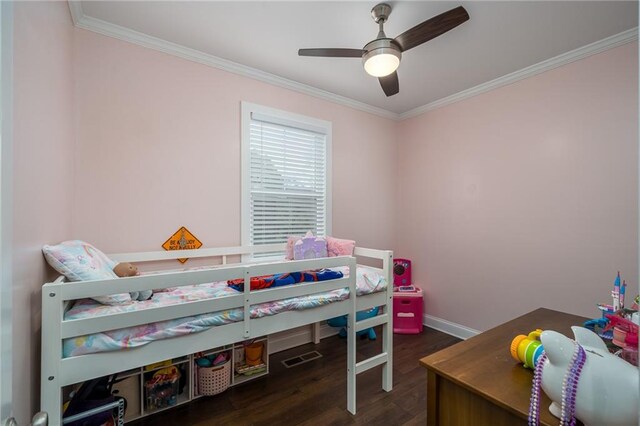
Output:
[{"xmin": 69, "ymin": 11, "xmax": 399, "ymax": 120}]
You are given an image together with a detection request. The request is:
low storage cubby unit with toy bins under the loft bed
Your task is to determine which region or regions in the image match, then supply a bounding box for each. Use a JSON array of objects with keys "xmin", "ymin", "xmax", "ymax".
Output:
[{"xmin": 65, "ymin": 336, "xmax": 269, "ymax": 422}]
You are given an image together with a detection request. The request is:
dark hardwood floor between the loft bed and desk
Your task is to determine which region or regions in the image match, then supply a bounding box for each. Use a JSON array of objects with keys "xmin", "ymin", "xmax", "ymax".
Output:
[{"xmin": 130, "ymin": 328, "xmax": 460, "ymax": 426}]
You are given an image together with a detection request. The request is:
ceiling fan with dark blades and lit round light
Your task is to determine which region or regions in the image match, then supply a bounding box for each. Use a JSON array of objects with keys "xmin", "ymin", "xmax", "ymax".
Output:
[{"xmin": 298, "ymin": 3, "xmax": 469, "ymax": 96}]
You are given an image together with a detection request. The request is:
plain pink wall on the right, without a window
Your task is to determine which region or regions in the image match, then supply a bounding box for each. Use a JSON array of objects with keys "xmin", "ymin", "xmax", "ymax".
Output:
[{"xmin": 396, "ymin": 43, "xmax": 638, "ymax": 332}]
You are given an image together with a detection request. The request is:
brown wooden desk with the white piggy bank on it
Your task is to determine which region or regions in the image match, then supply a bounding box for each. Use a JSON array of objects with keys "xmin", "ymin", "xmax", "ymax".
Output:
[{"xmin": 420, "ymin": 308, "xmax": 587, "ymax": 426}]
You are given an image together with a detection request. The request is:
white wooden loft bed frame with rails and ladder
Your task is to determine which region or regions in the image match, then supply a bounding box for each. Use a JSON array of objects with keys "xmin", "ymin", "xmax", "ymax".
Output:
[{"xmin": 40, "ymin": 244, "xmax": 393, "ymax": 425}]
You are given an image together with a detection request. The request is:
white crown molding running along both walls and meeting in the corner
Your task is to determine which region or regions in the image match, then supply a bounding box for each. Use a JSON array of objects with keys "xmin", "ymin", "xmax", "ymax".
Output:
[{"xmin": 69, "ymin": 1, "xmax": 638, "ymax": 121}]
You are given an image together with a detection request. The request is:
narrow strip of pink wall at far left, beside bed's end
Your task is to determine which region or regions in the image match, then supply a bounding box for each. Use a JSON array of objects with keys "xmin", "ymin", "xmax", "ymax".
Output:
[{"xmin": 13, "ymin": 2, "xmax": 74, "ymax": 424}]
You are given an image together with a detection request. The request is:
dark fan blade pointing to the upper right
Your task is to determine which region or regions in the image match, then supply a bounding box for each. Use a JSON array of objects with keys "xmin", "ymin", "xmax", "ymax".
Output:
[{"xmin": 394, "ymin": 6, "xmax": 469, "ymax": 52}]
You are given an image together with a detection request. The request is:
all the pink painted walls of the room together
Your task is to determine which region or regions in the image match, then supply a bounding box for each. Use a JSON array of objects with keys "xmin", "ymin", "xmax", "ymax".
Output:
[{"xmin": 14, "ymin": 2, "xmax": 638, "ymax": 422}]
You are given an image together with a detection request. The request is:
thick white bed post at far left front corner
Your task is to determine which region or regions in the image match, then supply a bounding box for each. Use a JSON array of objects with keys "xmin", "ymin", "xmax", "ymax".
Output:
[{"xmin": 40, "ymin": 278, "xmax": 63, "ymax": 425}]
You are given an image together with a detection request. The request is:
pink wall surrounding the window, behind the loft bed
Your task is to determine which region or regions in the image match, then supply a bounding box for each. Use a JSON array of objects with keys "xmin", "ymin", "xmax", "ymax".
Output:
[{"xmin": 73, "ymin": 30, "xmax": 397, "ymax": 252}]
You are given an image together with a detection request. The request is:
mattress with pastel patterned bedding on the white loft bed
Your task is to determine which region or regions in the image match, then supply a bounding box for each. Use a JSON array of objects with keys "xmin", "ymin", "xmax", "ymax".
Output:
[{"xmin": 63, "ymin": 266, "xmax": 387, "ymax": 358}]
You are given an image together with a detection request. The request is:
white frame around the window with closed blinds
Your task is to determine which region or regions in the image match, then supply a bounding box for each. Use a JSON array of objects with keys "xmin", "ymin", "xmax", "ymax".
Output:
[{"xmin": 240, "ymin": 101, "xmax": 332, "ymax": 261}]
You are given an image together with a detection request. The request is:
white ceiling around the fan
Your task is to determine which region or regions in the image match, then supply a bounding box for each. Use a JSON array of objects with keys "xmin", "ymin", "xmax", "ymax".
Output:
[{"xmin": 81, "ymin": 1, "xmax": 638, "ymax": 113}]
